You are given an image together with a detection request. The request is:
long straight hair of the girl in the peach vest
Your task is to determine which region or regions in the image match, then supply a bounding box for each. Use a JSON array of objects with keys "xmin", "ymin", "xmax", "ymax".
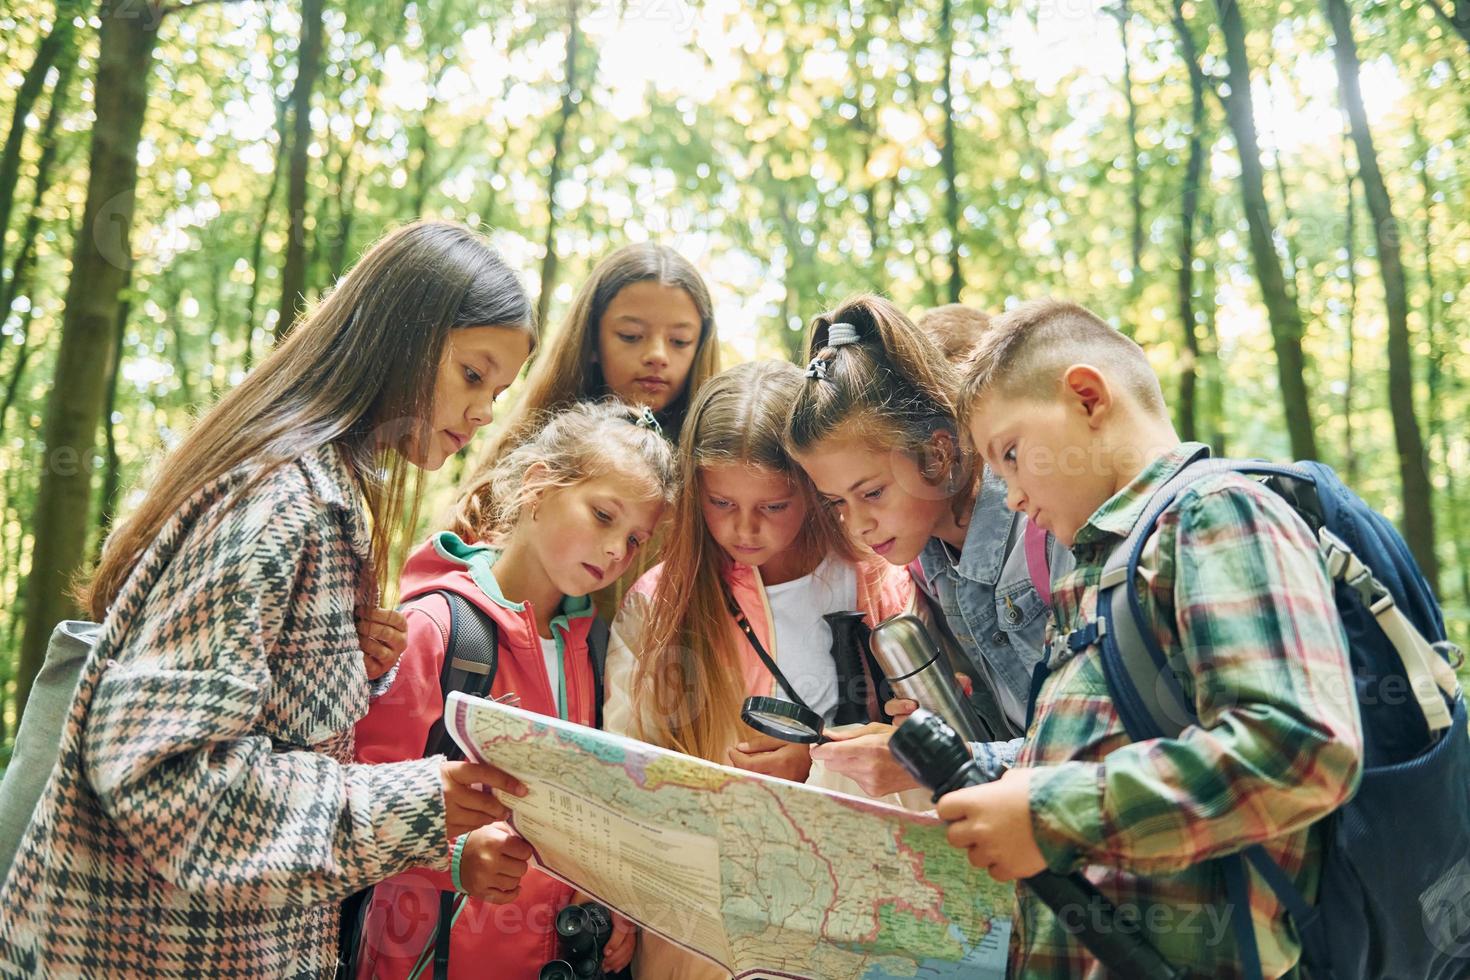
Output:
[{"xmin": 632, "ymin": 360, "xmax": 857, "ymax": 761}]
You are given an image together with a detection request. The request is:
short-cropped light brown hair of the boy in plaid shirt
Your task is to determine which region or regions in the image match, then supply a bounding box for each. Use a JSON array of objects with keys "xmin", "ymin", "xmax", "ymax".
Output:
[{"xmin": 960, "ymin": 298, "xmax": 1167, "ymax": 414}]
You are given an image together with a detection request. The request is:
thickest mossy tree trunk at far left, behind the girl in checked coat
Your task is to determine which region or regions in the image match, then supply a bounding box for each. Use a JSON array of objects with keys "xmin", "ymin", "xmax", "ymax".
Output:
[{"xmin": 16, "ymin": 1, "xmax": 160, "ymax": 714}]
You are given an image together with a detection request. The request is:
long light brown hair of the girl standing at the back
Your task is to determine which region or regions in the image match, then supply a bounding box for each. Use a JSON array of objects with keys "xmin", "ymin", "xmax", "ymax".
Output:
[{"xmin": 456, "ymin": 242, "xmax": 720, "ymax": 540}]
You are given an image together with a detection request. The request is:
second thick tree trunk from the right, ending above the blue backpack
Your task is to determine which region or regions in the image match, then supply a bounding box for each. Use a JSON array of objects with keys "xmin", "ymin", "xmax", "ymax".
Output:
[{"xmin": 1216, "ymin": 0, "xmax": 1317, "ymax": 460}]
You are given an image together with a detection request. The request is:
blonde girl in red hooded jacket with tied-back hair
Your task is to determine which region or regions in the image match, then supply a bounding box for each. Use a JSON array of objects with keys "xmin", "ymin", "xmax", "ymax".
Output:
[{"xmin": 357, "ymin": 403, "xmax": 675, "ymax": 980}]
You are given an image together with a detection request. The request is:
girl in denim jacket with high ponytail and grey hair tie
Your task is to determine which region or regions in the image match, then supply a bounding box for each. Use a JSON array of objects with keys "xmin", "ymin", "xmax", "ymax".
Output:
[{"xmin": 786, "ymin": 295, "xmax": 1072, "ymax": 793}]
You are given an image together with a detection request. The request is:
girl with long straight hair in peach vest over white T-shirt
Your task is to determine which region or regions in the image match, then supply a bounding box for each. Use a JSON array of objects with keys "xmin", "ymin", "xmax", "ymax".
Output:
[{"xmin": 604, "ymin": 361, "xmax": 914, "ymax": 980}]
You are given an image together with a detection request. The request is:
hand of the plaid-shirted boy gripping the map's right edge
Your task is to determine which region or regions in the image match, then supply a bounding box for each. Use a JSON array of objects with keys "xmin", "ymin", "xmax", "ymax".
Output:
[{"xmin": 938, "ymin": 768, "xmax": 1047, "ymax": 882}]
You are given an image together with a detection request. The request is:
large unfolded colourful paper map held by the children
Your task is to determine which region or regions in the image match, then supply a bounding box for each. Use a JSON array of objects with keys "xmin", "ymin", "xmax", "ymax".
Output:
[{"xmin": 445, "ymin": 693, "xmax": 1013, "ymax": 980}]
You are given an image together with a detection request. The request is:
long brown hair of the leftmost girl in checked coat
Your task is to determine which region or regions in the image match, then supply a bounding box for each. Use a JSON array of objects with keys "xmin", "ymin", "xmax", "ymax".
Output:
[{"xmin": 78, "ymin": 222, "xmax": 537, "ymax": 620}]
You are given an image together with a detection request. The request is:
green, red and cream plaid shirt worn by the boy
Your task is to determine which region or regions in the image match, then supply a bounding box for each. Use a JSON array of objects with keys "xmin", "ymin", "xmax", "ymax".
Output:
[{"xmin": 1011, "ymin": 445, "xmax": 1363, "ymax": 979}]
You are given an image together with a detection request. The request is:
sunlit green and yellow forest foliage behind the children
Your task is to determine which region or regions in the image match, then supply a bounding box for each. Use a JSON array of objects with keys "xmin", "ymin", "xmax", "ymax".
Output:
[{"xmin": 0, "ymin": 0, "xmax": 1470, "ymax": 741}]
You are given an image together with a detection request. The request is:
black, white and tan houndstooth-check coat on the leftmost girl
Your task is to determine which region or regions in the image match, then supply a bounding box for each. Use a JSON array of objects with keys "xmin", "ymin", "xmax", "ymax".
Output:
[{"xmin": 0, "ymin": 445, "xmax": 445, "ymax": 977}]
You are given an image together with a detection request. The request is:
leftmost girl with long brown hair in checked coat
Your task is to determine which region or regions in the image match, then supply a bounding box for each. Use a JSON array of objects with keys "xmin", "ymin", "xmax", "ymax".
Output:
[{"xmin": 0, "ymin": 223, "xmax": 537, "ymax": 977}]
